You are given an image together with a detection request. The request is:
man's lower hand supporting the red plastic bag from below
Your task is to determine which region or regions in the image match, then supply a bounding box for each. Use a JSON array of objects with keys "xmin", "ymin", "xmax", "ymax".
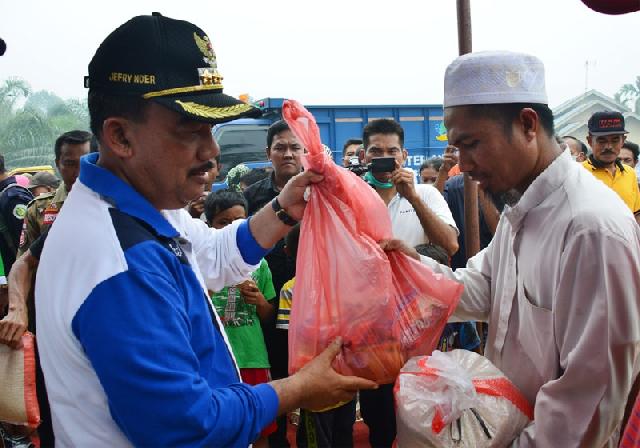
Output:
[{"xmin": 294, "ymin": 338, "xmax": 378, "ymax": 409}]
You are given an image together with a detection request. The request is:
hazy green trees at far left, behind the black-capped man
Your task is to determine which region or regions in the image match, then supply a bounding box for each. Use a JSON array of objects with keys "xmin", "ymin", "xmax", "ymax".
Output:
[{"xmin": 0, "ymin": 78, "xmax": 89, "ymax": 169}]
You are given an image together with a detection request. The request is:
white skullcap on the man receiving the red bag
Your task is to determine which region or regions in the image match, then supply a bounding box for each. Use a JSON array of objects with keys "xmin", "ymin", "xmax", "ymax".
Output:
[{"xmin": 444, "ymin": 51, "xmax": 548, "ymax": 107}]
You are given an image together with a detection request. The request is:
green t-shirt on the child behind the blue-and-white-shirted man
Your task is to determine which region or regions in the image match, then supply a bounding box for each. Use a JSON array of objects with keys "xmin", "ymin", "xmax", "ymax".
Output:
[{"xmin": 211, "ymin": 259, "xmax": 276, "ymax": 369}]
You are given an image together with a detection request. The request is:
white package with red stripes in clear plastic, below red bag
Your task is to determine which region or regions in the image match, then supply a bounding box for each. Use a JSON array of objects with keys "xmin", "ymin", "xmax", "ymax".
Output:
[{"xmin": 394, "ymin": 350, "xmax": 533, "ymax": 448}]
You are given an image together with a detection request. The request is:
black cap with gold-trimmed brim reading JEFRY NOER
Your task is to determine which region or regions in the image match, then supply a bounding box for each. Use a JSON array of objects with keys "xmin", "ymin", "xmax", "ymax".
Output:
[{"xmin": 84, "ymin": 12, "xmax": 260, "ymax": 124}]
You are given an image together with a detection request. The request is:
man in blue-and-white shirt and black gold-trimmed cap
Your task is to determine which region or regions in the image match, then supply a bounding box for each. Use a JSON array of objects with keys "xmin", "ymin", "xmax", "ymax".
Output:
[{"xmin": 36, "ymin": 13, "xmax": 375, "ymax": 447}]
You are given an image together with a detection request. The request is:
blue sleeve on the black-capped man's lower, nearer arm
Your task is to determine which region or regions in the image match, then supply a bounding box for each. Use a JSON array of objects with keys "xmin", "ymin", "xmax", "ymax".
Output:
[{"xmin": 72, "ymin": 270, "xmax": 278, "ymax": 447}]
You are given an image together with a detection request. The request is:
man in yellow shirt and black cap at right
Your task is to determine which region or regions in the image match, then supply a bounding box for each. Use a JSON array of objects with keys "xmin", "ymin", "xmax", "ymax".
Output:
[{"xmin": 582, "ymin": 111, "xmax": 640, "ymax": 222}]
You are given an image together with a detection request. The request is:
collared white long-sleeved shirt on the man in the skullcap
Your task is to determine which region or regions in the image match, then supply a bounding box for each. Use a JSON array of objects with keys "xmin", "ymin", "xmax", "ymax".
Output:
[{"xmin": 422, "ymin": 150, "xmax": 640, "ymax": 448}]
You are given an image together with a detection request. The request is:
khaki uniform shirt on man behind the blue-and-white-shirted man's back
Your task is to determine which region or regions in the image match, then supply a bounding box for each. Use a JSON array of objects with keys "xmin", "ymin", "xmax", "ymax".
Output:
[{"xmin": 18, "ymin": 183, "xmax": 68, "ymax": 256}]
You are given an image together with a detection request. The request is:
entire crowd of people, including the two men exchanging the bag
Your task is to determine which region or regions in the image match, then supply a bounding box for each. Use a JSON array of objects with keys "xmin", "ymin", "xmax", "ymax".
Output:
[{"xmin": 0, "ymin": 9, "xmax": 640, "ymax": 447}]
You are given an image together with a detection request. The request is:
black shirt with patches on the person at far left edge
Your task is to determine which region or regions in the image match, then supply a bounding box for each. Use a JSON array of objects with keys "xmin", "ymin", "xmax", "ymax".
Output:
[{"xmin": 0, "ymin": 176, "xmax": 33, "ymax": 274}]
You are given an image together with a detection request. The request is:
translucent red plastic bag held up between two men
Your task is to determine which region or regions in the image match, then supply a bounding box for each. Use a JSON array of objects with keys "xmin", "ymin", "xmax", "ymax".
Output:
[{"xmin": 282, "ymin": 100, "xmax": 462, "ymax": 384}]
